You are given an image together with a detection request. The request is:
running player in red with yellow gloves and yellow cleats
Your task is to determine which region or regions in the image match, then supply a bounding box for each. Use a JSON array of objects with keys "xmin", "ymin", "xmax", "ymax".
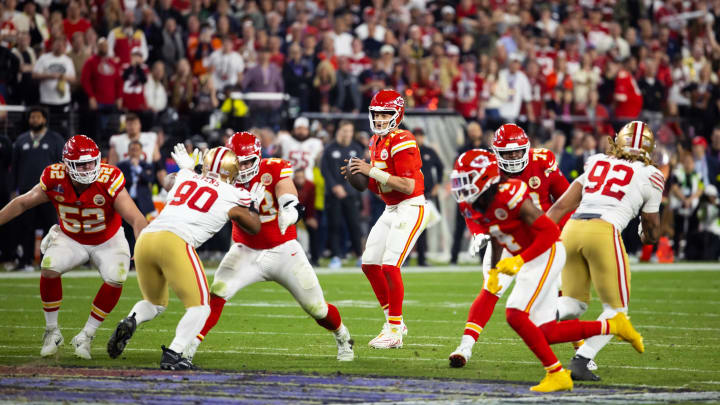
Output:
[{"xmin": 450, "ymin": 149, "xmax": 644, "ymax": 392}]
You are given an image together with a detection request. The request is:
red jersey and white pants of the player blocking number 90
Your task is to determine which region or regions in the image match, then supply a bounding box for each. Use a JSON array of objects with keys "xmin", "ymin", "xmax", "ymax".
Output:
[{"xmin": 210, "ymin": 158, "xmax": 328, "ymax": 319}]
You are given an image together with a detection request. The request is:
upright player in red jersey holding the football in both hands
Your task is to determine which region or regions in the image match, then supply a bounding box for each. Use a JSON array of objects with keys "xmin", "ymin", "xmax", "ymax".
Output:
[{"xmin": 343, "ymin": 90, "xmax": 427, "ymax": 349}]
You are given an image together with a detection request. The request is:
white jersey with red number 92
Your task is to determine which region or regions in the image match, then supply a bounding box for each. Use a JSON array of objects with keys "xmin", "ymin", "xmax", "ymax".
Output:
[{"xmin": 575, "ymin": 153, "xmax": 665, "ymax": 231}]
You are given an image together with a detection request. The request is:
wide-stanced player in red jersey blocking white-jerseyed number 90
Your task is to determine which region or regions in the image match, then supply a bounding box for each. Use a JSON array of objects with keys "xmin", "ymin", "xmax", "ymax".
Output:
[{"xmin": 183, "ymin": 132, "xmax": 355, "ymax": 361}]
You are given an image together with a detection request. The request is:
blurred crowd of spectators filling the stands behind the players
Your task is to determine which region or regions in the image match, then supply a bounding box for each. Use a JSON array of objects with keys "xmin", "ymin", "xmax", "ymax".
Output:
[{"xmin": 0, "ymin": 0, "xmax": 720, "ymax": 268}]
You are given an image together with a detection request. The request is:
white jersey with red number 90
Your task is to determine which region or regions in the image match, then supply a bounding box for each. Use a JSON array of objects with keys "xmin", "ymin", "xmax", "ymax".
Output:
[{"xmin": 143, "ymin": 169, "xmax": 251, "ymax": 248}]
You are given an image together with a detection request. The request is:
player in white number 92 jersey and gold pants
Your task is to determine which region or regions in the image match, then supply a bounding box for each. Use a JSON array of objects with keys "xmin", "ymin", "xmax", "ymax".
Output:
[{"xmin": 548, "ymin": 121, "xmax": 665, "ymax": 381}]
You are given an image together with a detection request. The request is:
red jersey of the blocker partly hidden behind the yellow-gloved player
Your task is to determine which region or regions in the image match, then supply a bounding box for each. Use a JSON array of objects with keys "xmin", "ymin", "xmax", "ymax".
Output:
[{"xmin": 503, "ymin": 148, "xmax": 570, "ymax": 212}]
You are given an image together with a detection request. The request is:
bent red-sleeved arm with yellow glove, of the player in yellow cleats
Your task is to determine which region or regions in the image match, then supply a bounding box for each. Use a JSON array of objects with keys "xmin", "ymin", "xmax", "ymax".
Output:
[{"xmin": 497, "ymin": 198, "xmax": 560, "ymax": 275}]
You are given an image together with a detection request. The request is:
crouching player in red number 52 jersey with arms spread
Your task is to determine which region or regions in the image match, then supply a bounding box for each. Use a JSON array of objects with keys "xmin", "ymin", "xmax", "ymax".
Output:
[{"xmin": 0, "ymin": 135, "xmax": 147, "ymax": 359}]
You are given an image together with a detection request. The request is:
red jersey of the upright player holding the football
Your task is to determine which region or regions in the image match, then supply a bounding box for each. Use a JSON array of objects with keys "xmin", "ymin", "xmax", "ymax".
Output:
[{"xmin": 368, "ymin": 129, "xmax": 425, "ymax": 205}]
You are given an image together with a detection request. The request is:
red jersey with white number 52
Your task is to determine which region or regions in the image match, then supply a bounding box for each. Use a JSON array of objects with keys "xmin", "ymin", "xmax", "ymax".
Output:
[{"xmin": 40, "ymin": 163, "xmax": 125, "ymax": 245}]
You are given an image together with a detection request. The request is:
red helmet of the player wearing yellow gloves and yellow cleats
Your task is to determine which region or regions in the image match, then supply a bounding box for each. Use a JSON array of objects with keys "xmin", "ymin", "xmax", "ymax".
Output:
[{"xmin": 450, "ymin": 149, "xmax": 500, "ymax": 204}]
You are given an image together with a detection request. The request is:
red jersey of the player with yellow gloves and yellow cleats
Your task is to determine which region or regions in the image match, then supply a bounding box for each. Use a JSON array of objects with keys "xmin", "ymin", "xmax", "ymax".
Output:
[{"xmin": 459, "ymin": 179, "xmax": 535, "ymax": 255}]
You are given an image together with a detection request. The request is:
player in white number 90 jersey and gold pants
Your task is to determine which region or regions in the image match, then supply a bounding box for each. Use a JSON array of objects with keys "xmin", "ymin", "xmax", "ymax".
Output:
[{"xmin": 107, "ymin": 144, "xmax": 262, "ymax": 370}]
